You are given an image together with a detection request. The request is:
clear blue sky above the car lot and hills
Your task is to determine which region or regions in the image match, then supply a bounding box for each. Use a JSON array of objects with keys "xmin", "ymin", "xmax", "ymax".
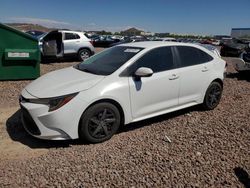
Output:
[{"xmin": 0, "ymin": 0, "xmax": 250, "ymax": 35}]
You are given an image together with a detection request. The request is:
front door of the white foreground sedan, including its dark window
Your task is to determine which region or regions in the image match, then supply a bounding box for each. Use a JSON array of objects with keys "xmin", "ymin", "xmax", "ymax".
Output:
[{"xmin": 129, "ymin": 47, "xmax": 179, "ymax": 119}]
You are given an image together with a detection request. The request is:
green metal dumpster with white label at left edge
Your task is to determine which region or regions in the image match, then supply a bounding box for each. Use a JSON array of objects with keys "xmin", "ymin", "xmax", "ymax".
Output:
[{"xmin": 0, "ymin": 23, "xmax": 41, "ymax": 80}]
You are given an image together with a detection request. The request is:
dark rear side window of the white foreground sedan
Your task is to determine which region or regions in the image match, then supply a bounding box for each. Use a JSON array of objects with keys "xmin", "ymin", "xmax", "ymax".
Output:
[{"xmin": 176, "ymin": 46, "xmax": 213, "ymax": 67}]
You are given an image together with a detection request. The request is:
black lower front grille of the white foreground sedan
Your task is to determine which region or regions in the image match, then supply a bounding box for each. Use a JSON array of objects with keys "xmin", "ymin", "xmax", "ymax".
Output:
[{"xmin": 21, "ymin": 107, "xmax": 41, "ymax": 135}]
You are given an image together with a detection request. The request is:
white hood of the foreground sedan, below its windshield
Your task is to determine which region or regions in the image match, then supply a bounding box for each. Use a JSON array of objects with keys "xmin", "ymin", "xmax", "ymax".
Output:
[{"xmin": 25, "ymin": 67, "xmax": 105, "ymax": 98}]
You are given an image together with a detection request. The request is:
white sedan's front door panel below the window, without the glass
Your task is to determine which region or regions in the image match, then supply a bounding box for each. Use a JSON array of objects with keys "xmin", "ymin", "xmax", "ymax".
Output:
[{"xmin": 129, "ymin": 70, "xmax": 179, "ymax": 119}]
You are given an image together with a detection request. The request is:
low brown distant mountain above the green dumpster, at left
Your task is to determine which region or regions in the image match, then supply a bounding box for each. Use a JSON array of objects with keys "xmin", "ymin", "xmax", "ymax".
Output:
[{"xmin": 5, "ymin": 23, "xmax": 55, "ymax": 32}]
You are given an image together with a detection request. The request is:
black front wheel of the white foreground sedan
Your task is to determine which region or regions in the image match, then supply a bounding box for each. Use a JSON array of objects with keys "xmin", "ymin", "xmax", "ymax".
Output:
[{"xmin": 79, "ymin": 102, "xmax": 121, "ymax": 143}]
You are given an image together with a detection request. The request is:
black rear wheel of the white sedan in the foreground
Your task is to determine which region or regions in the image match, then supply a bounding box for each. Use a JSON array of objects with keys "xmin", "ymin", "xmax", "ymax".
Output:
[{"xmin": 203, "ymin": 82, "xmax": 223, "ymax": 110}]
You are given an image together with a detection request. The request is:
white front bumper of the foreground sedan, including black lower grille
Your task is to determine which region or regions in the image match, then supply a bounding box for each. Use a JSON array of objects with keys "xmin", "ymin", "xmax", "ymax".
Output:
[{"xmin": 20, "ymin": 91, "xmax": 88, "ymax": 140}]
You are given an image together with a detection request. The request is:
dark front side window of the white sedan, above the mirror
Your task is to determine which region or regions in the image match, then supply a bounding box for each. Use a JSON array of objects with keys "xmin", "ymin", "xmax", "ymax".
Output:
[{"xmin": 133, "ymin": 47, "xmax": 174, "ymax": 72}]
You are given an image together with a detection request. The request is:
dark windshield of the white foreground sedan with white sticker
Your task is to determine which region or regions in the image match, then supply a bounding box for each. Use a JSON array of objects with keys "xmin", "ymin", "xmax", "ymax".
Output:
[{"xmin": 75, "ymin": 46, "xmax": 143, "ymax": 75}]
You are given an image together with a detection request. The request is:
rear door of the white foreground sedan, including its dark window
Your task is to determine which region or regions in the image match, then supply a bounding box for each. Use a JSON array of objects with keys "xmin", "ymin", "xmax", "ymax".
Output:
[{"xmin": 175, "ymin": 46, "xmax": 213, "ymax": 105}]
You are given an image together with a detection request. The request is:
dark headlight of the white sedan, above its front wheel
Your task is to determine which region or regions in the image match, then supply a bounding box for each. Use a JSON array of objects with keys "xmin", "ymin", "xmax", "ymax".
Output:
[{"xmin": 49, "ymin": 93, "xmax": 78, "ymax": 112}]
